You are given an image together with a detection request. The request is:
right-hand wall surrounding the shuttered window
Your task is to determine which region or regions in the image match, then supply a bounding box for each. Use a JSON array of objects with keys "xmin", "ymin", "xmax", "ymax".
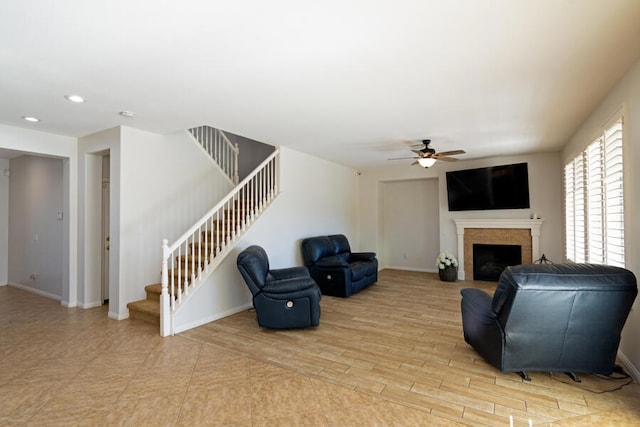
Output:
[{"xmin": 562, "ymin": 56, "xmax": 640, "ymax": 382}]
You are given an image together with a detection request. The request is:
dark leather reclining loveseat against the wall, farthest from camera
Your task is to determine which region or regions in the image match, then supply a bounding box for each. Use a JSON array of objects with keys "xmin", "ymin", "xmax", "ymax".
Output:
[{"xmin": 302, "ymin": 234, "xmax": 378, "ymax": 297}]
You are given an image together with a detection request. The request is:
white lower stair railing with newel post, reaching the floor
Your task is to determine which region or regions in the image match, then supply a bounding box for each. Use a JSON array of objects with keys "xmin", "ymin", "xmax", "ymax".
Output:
[{"xmin": 160, "ymin": 150, "xmax": 280, "ymax": 337}]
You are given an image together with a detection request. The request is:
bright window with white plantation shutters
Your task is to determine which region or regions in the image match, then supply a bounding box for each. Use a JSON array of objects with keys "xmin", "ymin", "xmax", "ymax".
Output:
[{"xmin": 564, "ymin": 113, "xmax": 624, "ymax": 267}]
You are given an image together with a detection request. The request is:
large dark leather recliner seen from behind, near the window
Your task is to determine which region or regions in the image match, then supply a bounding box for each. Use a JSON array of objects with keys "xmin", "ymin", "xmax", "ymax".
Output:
[{"xmin": 461, "ymin": 264, "xmax": 638, "ymax": 380}]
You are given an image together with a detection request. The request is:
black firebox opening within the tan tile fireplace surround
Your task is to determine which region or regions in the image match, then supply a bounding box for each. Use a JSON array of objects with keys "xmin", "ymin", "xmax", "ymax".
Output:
[{"xmin": 473, "ymin": 243, "xmax": 522, "ymax": 282}]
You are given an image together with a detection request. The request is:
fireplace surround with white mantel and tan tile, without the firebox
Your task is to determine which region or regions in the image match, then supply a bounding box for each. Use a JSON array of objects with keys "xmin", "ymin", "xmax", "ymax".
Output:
[{"xmin": 453, "ymin": 219, "xmax": 544, "ymax": 280}]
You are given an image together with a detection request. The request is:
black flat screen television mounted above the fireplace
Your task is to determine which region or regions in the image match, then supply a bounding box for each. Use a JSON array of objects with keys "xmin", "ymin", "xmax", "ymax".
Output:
[{"xmin": 447, "ymin": 163, "xmax": 529, "ymax": 211}]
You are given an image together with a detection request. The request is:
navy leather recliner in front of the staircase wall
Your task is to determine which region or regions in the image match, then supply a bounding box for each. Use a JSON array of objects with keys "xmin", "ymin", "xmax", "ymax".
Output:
[{"xmin": 237, "ymin": 245, "xmax": 322, "ymax": 329}]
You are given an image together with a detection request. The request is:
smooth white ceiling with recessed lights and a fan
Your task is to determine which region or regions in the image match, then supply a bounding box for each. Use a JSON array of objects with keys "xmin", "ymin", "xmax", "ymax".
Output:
[{"xmin": 0, "ymin": 0, "xmax": 640, "ymax": 169}]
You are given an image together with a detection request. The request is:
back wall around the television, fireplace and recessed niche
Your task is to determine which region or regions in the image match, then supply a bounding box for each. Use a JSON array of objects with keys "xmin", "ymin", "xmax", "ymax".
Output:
[{"xmin": 359, "ymin": 153, "xmax": 563, "ymax": 266}]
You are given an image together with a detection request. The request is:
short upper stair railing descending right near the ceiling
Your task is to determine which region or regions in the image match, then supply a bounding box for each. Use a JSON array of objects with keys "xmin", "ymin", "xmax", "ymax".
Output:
[{"xmin": 189, "ymin": 126, "xmax": 240, "ymax": 184}]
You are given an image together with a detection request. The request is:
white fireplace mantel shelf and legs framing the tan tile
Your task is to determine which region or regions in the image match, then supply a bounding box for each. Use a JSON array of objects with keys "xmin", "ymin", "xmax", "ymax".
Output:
[{"xmin": 453, "ymin": 219, "xmax": 544, "ymax": 280}]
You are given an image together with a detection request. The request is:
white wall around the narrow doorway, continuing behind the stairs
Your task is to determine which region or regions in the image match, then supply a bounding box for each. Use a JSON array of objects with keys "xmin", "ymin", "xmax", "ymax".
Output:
[{"xmin": 79, "ymin": 127, "xmax": 230, "ymax": 319}]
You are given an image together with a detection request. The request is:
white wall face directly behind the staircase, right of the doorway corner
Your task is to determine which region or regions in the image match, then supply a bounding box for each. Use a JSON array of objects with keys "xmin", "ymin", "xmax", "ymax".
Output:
[{"xmin": 117, "ymin": 127, "xmax": 231, "ymax": 317}]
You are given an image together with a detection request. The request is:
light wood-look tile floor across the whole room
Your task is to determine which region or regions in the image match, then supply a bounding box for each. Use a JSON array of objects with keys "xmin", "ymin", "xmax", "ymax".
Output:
[{"xmin": 0, "ymin": 270, "xmax": 640, "ymax": 426}]
